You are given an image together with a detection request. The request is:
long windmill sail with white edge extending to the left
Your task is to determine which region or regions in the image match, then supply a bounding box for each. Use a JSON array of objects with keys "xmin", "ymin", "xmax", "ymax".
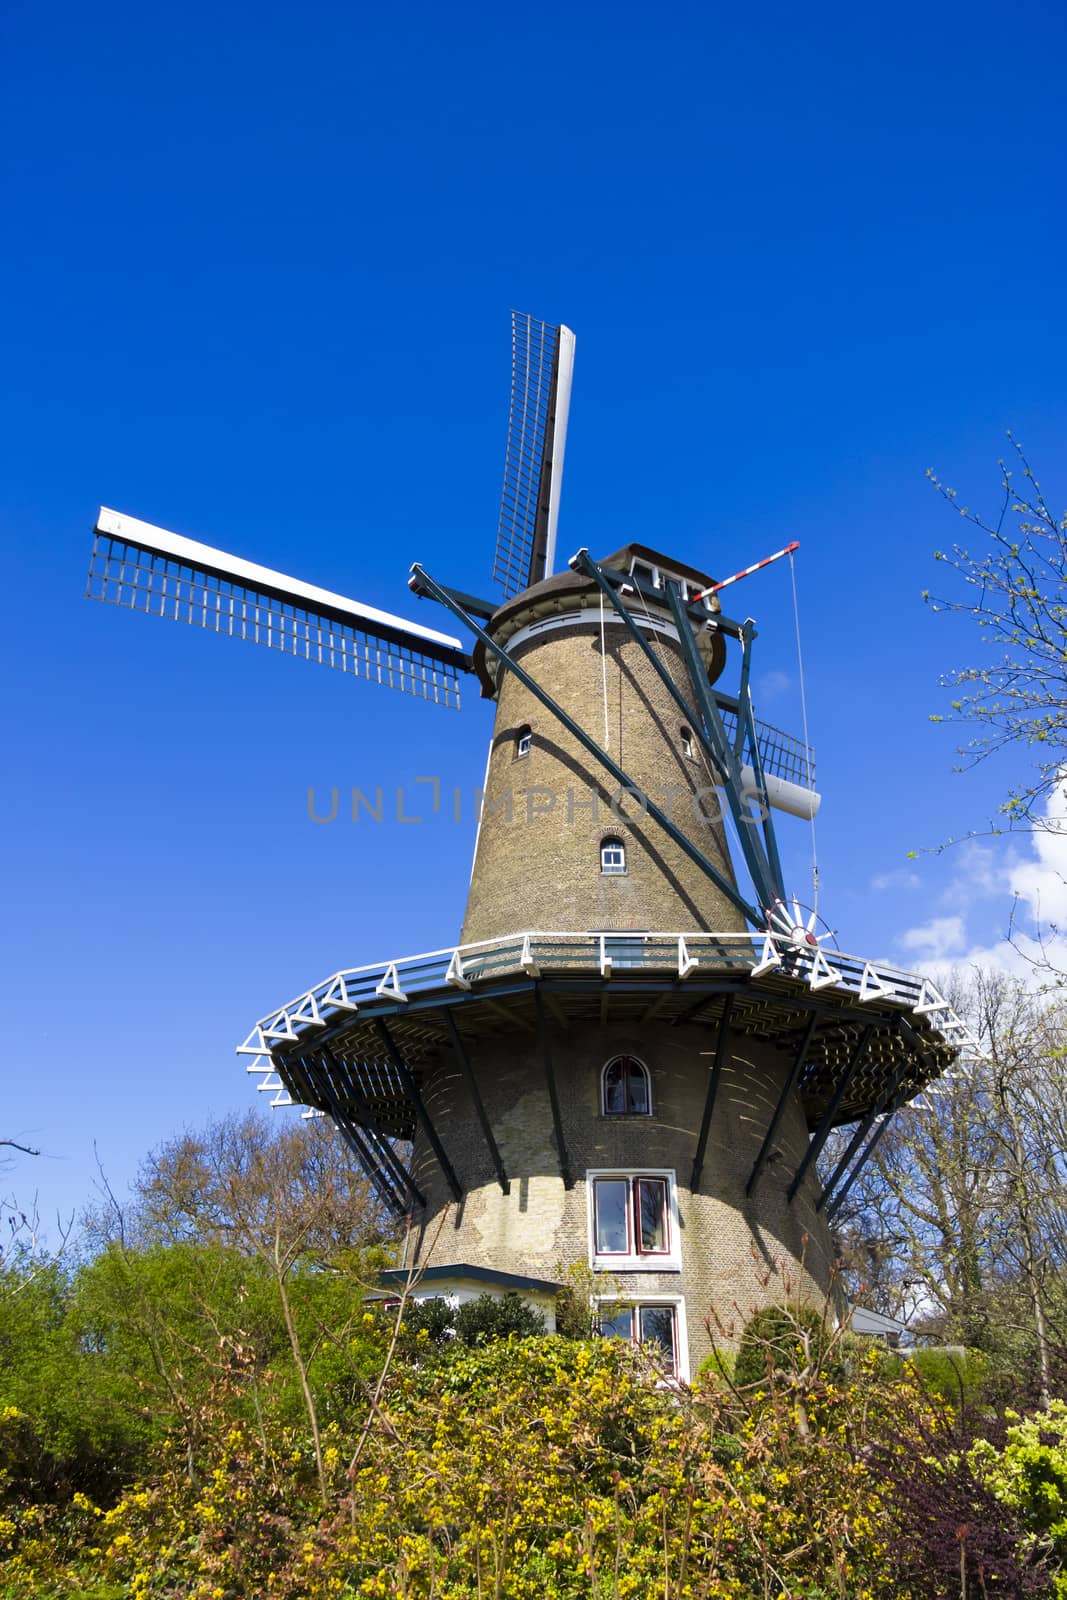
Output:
[{"xmin": 86, "ymin": 506, "xmax": 470, "ymax": 707}]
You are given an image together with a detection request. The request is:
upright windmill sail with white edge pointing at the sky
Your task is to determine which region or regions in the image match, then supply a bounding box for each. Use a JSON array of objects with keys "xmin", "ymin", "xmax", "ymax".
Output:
[{"xmin": 493, "ymin": 310, "xmax": 574, "ymax": 597}]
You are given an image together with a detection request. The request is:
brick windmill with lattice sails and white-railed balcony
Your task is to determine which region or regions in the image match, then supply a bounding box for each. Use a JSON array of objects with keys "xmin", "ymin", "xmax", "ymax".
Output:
[{"xmin": 88, "ymin": 314, "xmax": 973, "ymax": 1376}]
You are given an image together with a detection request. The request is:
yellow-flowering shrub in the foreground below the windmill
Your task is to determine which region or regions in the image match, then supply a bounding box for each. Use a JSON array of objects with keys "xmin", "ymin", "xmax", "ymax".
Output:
[{"xmin": 0, "ymin": 1338, "xmax": 940, "ymax": 1600}]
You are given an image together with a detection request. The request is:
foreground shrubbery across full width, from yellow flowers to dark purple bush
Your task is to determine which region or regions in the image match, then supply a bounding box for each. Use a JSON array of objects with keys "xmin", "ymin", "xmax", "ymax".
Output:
[{"xmin": 0, "ymin": 1314, "xmax": 1067, "ymax": 1600}]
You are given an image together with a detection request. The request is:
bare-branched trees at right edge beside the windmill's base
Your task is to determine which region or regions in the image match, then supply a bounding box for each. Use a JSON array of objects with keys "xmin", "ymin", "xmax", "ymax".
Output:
[{"xmin": 838, "ymin": 970, "xmax": 1067, "ymax": 1405}]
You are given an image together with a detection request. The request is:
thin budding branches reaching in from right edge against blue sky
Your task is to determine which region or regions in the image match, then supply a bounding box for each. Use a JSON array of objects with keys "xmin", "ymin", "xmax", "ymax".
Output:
[{"xmin": 923, "ymin": 432, "xmax": 1067, "ymax": 827}]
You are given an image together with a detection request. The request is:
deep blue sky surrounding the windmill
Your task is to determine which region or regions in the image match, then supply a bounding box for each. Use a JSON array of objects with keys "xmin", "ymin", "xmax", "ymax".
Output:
[{"xmin": 0, "ymin": 0, "xmax": 1067, "ymax": 1210}]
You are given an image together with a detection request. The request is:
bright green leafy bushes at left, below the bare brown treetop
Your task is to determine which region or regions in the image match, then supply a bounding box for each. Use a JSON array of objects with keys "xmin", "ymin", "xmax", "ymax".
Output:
[{"xmin": 0, "ymin": 1243, "xmax": 379, "ymax": 1501}]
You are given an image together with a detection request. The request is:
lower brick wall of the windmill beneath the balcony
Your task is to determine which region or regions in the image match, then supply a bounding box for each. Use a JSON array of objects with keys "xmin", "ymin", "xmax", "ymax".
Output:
[{"xmin": 416, "ymin": 1026, "xmax": 832, "ymax": 1371}]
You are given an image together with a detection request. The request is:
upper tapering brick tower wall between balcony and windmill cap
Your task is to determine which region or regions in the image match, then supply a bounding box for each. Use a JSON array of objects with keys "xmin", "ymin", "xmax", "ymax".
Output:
[{"xmin": 462, "ymin": 608, "xmax": 744, "ymax": 944}]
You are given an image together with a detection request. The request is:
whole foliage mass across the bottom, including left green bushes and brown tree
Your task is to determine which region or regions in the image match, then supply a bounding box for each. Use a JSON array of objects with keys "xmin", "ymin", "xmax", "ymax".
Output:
[{"xmin": 0, "ymin": 1120, "xmax": 1067, "ymax": 1600}]
